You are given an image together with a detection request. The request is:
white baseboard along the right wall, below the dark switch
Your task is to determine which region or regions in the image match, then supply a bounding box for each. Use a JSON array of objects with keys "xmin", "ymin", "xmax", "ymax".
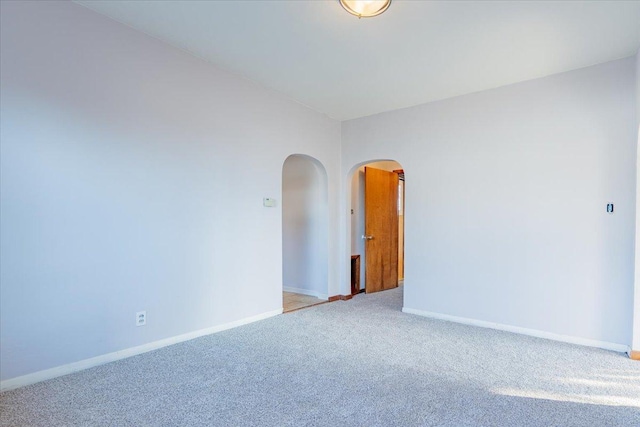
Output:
[{"xmin": 402, "ymin": 307, "xmax": 630, "ymax": 353}]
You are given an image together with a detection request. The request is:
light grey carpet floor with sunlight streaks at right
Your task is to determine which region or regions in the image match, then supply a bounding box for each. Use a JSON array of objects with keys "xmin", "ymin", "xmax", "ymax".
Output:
[{"xmin": 0, "ymin": 288, "xmax": 640, "ymax": 427}]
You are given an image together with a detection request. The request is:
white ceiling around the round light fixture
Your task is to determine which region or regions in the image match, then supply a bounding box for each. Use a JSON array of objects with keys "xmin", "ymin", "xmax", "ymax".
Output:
[{"xmin": 76, "ymin": 0, "xmax": 640, "ymax": 120}]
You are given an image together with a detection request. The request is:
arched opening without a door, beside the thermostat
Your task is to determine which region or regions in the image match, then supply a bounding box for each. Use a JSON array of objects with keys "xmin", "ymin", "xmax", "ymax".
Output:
[{"xmin": 282, "ymin": 154, "xmax": 329, "ymax": 312}]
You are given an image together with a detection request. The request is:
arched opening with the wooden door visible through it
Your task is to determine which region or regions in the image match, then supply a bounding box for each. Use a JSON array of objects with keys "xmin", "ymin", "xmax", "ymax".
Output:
[{"xmin": 347, "ymin": 160, "xmax": 405, "ymax": 294}]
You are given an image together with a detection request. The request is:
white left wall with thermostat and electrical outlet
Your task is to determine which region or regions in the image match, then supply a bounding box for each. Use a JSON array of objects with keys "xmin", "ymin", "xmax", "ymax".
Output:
[{"xmin": 0, "ymin": 1, "xmax": 342, "ymax": 380}]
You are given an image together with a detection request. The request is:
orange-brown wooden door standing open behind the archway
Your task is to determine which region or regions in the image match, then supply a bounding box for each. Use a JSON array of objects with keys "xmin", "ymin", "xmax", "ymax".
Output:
[{"xmin": 363, "ymin": 167, "xmax": 398, "ymax": 293}]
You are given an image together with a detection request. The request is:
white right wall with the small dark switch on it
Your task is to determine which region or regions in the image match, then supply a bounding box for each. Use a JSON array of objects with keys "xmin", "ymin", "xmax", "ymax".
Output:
[{"xmin": 342, "ymin": 58, "xmax": 637, "ymax": 345}]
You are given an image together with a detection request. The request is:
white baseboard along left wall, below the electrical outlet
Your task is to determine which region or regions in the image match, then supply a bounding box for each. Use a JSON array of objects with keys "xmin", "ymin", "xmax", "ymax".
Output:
[{"xmin": 0, "ymin": 309, "xmax": 282, "ymax": 392}]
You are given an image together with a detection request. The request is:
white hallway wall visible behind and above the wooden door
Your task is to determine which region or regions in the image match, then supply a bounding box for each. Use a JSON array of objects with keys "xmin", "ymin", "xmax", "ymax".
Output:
[{"xmin": 351, "ymin": 160, "xmax": 402, "ymax": 289}]
